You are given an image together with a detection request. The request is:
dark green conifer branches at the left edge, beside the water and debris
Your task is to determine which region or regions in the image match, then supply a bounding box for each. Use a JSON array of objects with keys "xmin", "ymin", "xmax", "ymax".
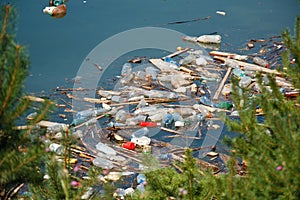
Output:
[{"xmin": 0, "ymin": 5, "xmax": 51, "ymax": 199}]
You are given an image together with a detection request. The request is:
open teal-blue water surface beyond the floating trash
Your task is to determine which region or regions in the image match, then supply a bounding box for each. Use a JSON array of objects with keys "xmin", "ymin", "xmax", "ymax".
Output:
[{"xmin": 2, "ymin": 0, "xmax": 299, "ymax": 93}]
